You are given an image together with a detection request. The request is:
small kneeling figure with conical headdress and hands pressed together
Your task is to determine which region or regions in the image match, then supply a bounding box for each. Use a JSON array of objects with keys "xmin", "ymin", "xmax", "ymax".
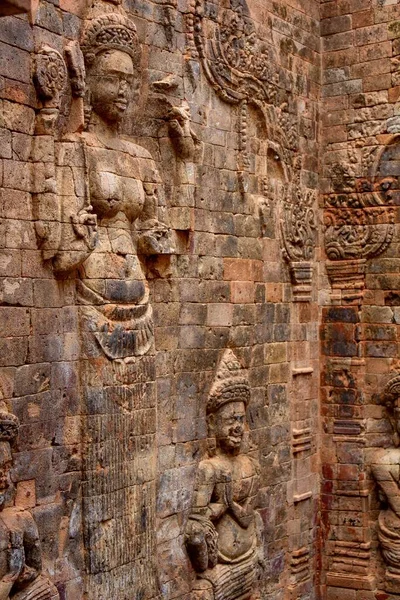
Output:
[{"xmin": 186, "ymin": 350, "xmax": 261, "ymax": 600}]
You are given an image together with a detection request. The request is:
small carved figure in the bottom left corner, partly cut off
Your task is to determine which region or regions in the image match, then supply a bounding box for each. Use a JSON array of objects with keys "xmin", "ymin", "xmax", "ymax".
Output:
[{"xmin": 0, "ymin": 408, "xmax": 59, "ymax": 600}]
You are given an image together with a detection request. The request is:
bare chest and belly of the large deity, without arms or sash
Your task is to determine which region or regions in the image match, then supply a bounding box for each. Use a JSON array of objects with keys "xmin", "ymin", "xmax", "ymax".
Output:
[{"xmin": 81, "ymin": 138, "xmax": 148, "ymax": 304}]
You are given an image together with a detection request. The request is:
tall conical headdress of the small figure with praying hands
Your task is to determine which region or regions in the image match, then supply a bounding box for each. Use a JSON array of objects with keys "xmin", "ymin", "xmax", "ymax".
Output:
[{"xmin": 207, "ymin": 349, "xmax": 250, "ymax": 414}]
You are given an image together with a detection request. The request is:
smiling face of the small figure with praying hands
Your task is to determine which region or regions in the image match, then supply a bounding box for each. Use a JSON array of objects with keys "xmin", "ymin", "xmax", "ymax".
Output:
[{"xmin": 214, "ymin": 400, "xmax": 246, "ymax": 454}]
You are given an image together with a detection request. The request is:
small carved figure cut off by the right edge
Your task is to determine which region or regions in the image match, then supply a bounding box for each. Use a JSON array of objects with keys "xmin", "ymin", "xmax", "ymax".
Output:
[{"xmin": 371, "ymin": 376, "xmax": 400, "ymax": 581}]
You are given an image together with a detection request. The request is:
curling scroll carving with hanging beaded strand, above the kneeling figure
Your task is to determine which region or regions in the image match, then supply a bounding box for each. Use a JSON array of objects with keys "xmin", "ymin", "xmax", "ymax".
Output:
[{"xmin": 187, "ymin": 0, "xmax": 316, "ymax": 300}]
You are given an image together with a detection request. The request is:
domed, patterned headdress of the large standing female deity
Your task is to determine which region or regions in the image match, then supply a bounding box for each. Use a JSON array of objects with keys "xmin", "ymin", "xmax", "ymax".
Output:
[{"xmin": 81, "ymin": 12, "xmax": 140, "ymax": 66}]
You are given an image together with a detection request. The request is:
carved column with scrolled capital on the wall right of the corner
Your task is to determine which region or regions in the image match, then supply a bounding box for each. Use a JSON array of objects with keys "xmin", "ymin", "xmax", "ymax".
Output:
[{"xmin": 321, "ymin": 139, "xmax": 396, "ymax": 593}]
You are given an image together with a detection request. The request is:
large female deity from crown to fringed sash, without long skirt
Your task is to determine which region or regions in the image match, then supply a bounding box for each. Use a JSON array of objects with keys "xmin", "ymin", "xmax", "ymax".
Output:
[{"xmin": 53, "ymin": 9, "xmax": 172, "ymax": 359}]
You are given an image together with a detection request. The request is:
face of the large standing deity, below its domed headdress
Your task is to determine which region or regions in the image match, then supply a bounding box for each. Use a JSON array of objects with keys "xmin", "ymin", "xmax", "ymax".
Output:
[{"xmin": 88, "ymin": 50, "xmax": 134, "ymax": 124}]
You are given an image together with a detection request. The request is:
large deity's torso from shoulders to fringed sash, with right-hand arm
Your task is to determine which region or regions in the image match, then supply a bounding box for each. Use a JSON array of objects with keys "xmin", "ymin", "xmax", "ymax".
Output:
[{"xmin": 78, "ymin": 133, "xmax": 166, "ymax": 358}]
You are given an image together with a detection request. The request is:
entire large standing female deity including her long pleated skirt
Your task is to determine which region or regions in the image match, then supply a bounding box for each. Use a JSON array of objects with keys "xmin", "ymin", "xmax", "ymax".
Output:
[{"xmin": 32, "ymin": 5, "xmax": 187, "ymax": 600}]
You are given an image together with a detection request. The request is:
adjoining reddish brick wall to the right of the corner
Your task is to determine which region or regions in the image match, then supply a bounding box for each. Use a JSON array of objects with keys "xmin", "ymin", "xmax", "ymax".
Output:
[{"xmin": 320, "ymin": 1, "xmax": 400, "ymax": 599}]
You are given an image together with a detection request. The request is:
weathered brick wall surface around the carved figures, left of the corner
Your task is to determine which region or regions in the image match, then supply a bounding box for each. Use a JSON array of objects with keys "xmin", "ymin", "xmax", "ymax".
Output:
[{"xmin": 0, "ymin": 0, "xmax": 324, "ymax": 600}]
